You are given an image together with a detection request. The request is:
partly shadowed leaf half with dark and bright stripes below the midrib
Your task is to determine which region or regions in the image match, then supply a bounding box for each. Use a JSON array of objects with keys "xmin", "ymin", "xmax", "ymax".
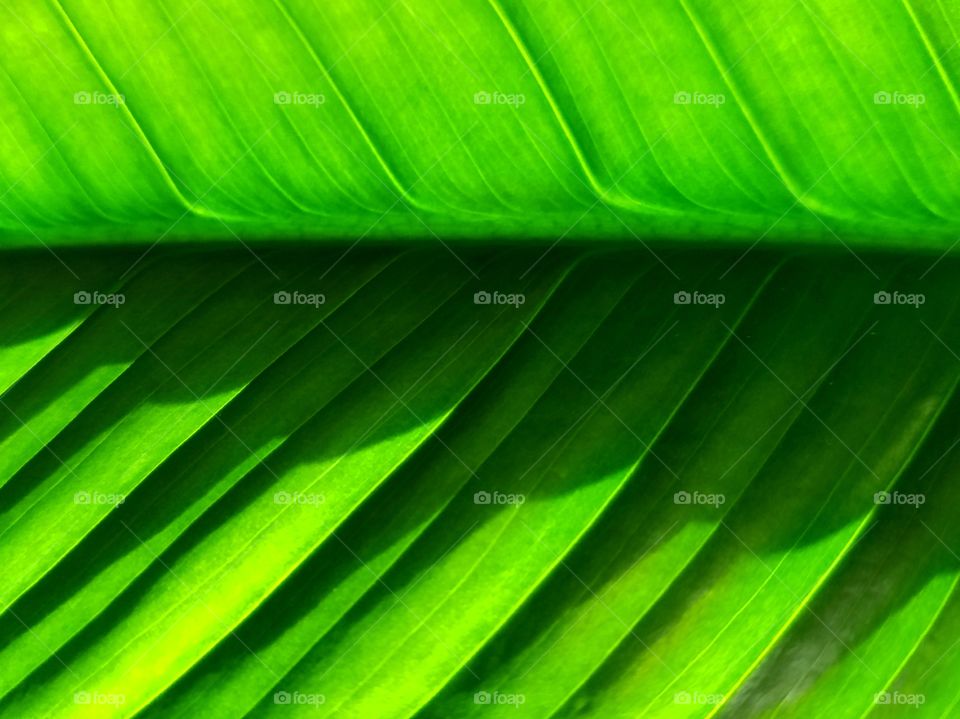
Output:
[{"xmin": 0, "ymin": 243, "xmax": 960, "ymax": 719}]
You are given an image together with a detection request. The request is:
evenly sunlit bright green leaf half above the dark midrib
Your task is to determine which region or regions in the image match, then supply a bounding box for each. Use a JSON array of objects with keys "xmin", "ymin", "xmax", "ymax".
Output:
[{"xmin": 0, "ymin": 0, "xmax": 960, "ymax": 249}]
